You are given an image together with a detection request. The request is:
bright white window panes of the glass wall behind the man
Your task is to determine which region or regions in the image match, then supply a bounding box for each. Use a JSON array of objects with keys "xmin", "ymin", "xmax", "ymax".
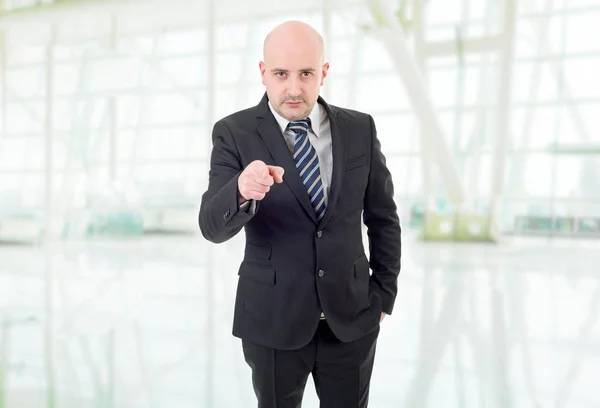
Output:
[{"xmin": 0, "ymin": 0, "xmax": 600, "ymax": 236}]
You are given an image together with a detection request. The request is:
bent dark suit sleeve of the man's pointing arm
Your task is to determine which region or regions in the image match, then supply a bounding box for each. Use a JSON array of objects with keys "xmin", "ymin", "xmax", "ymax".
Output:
[{"xmin": 198, "ymin": 121, "xmax": 259, "ymax": 243}]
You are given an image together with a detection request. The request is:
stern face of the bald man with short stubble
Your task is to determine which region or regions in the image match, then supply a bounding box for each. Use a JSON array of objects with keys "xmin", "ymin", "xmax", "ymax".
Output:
[{"xmin": 260, "ymin": 39, "xmax": 329, "ymax": 121}]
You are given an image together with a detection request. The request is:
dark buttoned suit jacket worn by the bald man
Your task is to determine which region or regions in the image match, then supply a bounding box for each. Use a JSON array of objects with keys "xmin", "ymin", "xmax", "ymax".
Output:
[{"xmin": 199, "ymin": 94, "xmax": 401, "ymax": 349}]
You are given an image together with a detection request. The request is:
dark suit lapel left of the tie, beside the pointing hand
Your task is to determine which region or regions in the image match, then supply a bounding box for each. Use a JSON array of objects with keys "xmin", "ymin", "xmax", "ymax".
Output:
[{"xmin": 257, "ymin": 94, "xmax": 317, "ymax": 223}]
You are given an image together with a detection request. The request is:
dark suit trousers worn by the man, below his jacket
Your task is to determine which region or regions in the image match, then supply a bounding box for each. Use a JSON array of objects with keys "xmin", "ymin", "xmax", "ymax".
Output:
[{"xmin": 242, "ymin": 320, "xmax": 380, "ymax": 408}]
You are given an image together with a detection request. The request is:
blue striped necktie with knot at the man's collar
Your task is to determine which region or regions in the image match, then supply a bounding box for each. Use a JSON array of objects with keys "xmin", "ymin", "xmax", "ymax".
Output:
[{"xmin": 288, "ymin": 119, "xmax": 326, "ymax": 220}]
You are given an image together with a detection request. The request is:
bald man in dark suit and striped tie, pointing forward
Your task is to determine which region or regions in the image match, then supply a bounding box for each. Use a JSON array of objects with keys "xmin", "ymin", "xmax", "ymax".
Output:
[{"xmin": 199, "ymin": 21, "xmax": 400, "ymax": 408}]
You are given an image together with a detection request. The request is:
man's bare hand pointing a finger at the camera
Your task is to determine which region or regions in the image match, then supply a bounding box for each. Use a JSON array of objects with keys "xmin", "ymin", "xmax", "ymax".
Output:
[{"xmin": 238, "ymin": 160, "xmax": 283, "ymax": 204}]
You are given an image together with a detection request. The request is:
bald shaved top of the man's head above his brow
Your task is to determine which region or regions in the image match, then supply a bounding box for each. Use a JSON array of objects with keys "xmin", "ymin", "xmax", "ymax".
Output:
[{"xmin": 263, "ymin": 20, "xmax": 325, "ymax": 64}]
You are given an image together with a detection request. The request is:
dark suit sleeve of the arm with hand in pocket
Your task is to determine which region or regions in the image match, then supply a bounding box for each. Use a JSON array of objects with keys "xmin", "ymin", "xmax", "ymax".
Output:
[{"xmin": 363, "ymin": 116, "xmax": 401, "ymax": 314}]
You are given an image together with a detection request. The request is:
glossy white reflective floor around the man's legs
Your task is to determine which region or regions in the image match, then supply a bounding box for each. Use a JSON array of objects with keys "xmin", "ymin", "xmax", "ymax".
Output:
[{"xmin": 0, "ymin": 236, "xmax": 600, "ymax": 408}]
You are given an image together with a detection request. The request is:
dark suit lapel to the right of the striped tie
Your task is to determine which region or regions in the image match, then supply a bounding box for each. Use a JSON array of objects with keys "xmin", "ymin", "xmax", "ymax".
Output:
[{"xmin": 318, "ymin": 97, "xmax": 347, "ymax": 229}]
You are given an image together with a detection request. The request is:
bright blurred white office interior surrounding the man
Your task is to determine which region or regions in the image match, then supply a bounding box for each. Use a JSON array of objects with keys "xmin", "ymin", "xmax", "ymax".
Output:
[{"xmin": 0, "ymin": 0, "xmax": 600, "ymax": 408}]
